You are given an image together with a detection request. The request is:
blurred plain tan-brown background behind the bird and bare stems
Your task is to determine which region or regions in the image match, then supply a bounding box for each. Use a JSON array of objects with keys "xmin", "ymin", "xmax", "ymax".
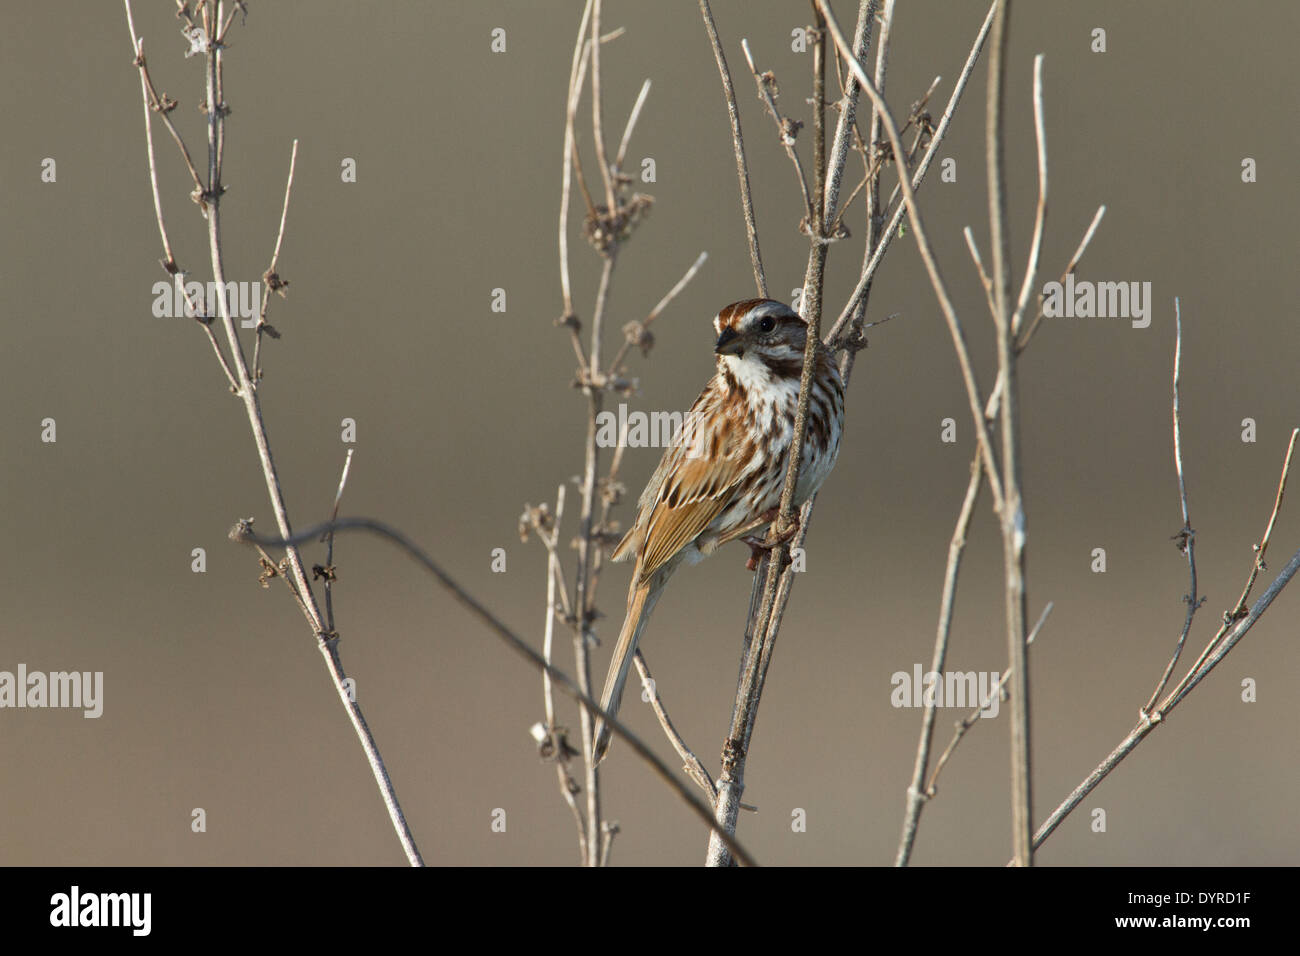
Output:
[{"xmin": 0, "ymin": 0, "xmax": 1300, "ymax": 865}]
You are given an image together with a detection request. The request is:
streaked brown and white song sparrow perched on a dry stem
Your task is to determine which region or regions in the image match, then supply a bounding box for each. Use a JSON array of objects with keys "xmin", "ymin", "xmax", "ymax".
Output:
[{"xmin": 593, "ymin": 299, "xmax": 844, "ymax": 761}]
